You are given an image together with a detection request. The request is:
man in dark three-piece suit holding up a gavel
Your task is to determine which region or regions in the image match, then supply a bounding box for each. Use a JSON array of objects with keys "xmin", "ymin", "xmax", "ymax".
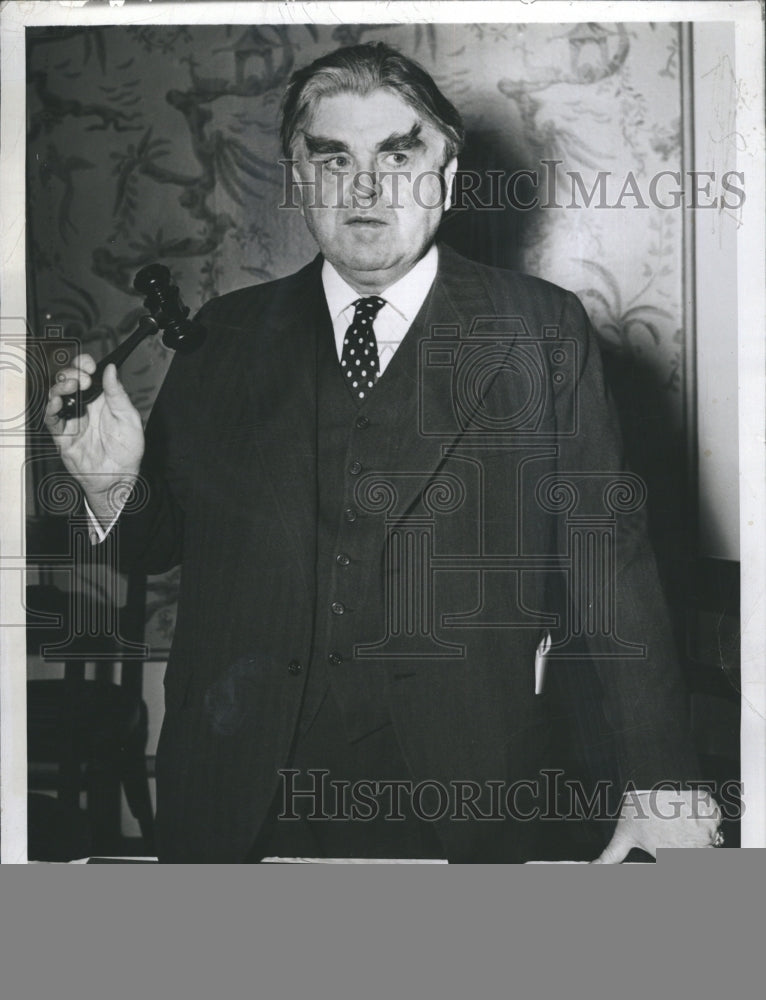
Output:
[{"xmin": 48, "ymin": 45, "xmax": 718, "ymax": 862}]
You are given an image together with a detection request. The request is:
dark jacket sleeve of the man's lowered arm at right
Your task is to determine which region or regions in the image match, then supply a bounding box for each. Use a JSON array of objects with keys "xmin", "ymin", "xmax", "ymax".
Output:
[{"xmin": 557, "ymin": 294, "xmax": 698, "ymax": 788}]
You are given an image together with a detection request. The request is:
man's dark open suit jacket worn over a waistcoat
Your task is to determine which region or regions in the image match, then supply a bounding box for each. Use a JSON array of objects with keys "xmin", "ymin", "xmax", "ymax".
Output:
[{"xmin": 118, "ymin": 247, "xmax": 694, "ymax": 862}]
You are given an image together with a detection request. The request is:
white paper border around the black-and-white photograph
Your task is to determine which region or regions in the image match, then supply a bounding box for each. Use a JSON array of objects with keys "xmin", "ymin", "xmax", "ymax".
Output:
[{"xmin": 0, "ymin": 0, "xmax": 766, "ymax": 864}]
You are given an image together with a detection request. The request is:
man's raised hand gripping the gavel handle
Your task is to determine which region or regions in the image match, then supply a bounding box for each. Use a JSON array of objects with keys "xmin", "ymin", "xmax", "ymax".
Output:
[{"xmin": 45, "ymin": 354, "xmax": 144, "ymax": 526}]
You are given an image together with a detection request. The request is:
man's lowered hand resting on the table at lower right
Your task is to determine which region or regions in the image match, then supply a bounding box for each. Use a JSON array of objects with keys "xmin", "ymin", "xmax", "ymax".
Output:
[{"xmin": 592, "ymin": 789, "xmax": 722, "ymax": 865}]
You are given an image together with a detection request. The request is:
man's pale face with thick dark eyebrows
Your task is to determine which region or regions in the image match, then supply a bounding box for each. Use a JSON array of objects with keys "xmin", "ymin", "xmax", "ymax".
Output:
[{"xmin": 295, "ymin": 90, "xmax": 457, "ymax": 293}]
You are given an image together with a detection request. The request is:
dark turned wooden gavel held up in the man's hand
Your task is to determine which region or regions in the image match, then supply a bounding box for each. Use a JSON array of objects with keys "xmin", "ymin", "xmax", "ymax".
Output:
[{"xmin": 58, "ymin": 264, "xmax": 205, "ymax": 420}]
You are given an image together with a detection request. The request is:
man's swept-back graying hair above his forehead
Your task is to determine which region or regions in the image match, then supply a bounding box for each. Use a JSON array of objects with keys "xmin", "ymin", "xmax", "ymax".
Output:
[{"xmin": 280, "ymin": 42, "xmax": 465, "ymax": 162}]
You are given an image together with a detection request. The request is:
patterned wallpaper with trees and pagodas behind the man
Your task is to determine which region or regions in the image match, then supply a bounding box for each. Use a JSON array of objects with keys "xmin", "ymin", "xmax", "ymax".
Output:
[{"xmin": 28, "ymin": 23, "xmax": 684, "ymax": 644}]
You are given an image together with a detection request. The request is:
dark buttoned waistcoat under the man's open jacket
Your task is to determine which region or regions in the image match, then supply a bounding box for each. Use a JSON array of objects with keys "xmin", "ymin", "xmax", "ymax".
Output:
[{"xmin": 299, "ymin": 295, "xmax": 430, "ymax": 741}]
